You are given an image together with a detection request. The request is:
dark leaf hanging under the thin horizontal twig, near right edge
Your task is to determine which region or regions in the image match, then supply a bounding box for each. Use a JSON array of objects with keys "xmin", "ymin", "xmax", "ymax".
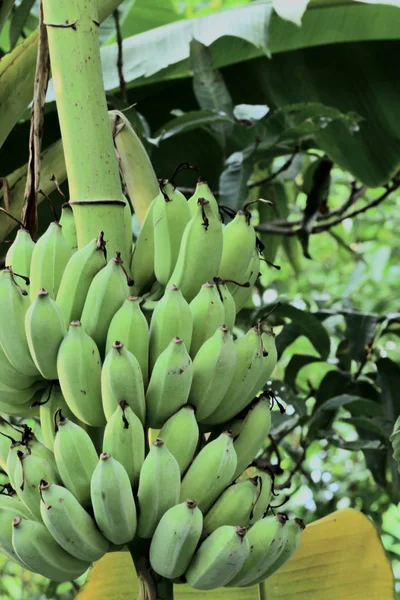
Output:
[{"xmin": 343, "ymin": 310, "xmax": 379, "ymax": 362}]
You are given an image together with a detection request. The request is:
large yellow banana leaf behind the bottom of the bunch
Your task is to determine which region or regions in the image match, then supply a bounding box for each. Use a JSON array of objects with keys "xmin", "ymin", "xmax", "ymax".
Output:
[{"xmin": 77, "ymin": 509, "xmax": 395, "ymax": 600}]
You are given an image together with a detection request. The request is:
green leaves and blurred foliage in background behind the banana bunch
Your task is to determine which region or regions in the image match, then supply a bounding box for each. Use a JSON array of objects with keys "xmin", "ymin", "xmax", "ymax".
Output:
[{"xmin": 0, "ymin": 0, "xmax": 400, "ymax": 600}]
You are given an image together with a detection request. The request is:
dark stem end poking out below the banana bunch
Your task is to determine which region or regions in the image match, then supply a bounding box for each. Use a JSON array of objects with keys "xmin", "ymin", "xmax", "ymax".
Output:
[{"xmin": 128, "ymin": 538, "xmax": 174, "ymax": 600}]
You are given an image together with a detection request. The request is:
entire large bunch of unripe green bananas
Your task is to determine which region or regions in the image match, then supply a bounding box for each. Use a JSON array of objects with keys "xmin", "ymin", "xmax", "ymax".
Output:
[{"xmin": 0, "ymin": 173, "xmax": 303, "ymax": 590}]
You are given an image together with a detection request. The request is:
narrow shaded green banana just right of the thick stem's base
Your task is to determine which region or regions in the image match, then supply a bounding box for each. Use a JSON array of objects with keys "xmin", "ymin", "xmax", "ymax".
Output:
[{"xmin": 131, "ymin": 192, "xmax": 158, "ymax": 296}]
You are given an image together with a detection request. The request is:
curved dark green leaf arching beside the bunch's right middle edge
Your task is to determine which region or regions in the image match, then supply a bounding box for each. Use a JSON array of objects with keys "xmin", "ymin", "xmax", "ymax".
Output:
[{"xmin": 272, "ymin": 304, "xmax": 330, "ymax": 360}]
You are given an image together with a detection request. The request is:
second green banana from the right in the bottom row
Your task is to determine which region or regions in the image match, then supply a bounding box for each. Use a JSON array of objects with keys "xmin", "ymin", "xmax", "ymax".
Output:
[{"xmin": 229, "ymin": 514, "xmax": 287, "ymax": 587}]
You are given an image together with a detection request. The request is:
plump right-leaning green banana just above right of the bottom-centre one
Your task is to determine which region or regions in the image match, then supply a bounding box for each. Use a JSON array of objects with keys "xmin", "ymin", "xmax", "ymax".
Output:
[{"xmin": 181, "ymin": 432, "xmax": 237, "ymax": 514}]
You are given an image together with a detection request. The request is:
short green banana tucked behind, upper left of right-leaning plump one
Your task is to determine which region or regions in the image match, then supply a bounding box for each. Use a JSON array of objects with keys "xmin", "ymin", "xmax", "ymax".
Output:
[{"xmin": 158, "ymin": 404, "xmax": 199, "ymax": 474}]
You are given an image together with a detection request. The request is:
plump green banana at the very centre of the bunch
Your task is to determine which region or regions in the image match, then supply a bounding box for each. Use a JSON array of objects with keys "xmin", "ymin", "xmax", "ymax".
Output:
[{"xmin": 146, "ymin": 337, "xmax": 193, "ymax": 429}]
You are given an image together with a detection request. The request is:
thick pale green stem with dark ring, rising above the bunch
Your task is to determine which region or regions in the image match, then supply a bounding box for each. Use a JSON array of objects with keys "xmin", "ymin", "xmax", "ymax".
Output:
[{"xmin": 43, "ymin": 0, "xmax": 129, "ymax": 261}]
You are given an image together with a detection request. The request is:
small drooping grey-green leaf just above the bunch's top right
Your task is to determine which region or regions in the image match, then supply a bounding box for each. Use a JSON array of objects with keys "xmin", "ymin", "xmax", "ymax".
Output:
[{"xmin": 219, "ymin": 152, "xmax": 253, "ymax": 210}]
